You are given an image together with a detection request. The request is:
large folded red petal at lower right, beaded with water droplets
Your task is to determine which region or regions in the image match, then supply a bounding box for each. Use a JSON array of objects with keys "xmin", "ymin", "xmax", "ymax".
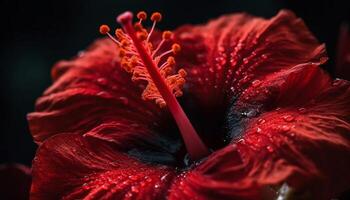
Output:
[{"xmin": 170, "ymin": 63, "xmax": 350, "ymax": 199}]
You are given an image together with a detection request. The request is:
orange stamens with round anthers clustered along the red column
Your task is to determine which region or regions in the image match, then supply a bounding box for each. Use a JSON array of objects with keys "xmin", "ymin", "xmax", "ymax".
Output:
[{"xmin": 100, "ymin": 11, "xmax": 187, "ymax": 108}]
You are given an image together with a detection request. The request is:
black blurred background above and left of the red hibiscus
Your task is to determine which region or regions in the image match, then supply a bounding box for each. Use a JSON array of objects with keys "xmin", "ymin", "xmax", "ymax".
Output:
[{"xmin": 0, "ymin": 0, "xmax": 350, "ymax": 165}]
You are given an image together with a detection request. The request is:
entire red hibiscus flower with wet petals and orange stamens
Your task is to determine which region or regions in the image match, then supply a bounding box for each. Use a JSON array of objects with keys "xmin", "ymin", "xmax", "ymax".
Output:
[{"xmin": 28, "ymin": 11, "xmax": 350, "ymax": 199}]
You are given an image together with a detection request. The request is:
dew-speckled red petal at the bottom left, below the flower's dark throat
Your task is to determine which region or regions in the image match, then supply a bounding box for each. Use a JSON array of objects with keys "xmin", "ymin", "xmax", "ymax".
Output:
[{"xmin": 31, "ymin": 134, "xmax": 174, "ymax": 200}]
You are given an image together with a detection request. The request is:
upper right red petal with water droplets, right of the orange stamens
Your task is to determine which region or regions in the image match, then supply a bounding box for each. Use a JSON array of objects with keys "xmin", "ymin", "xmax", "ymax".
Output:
[{"xmin": 175, "ymin": 10, "xmax": 327, "ymax": 107}]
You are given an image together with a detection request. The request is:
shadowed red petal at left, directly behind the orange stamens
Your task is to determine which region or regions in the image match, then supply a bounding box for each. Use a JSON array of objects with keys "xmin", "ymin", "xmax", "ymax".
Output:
[{"xmin": 28, "ymin": 40, "xmax": 161, "ymax": 143}]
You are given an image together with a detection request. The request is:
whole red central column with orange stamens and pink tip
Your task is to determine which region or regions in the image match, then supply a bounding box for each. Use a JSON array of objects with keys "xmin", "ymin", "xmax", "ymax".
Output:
[{"xmin": 100, "ymin": 11, "xmax": 209, "ymax": 160}]
